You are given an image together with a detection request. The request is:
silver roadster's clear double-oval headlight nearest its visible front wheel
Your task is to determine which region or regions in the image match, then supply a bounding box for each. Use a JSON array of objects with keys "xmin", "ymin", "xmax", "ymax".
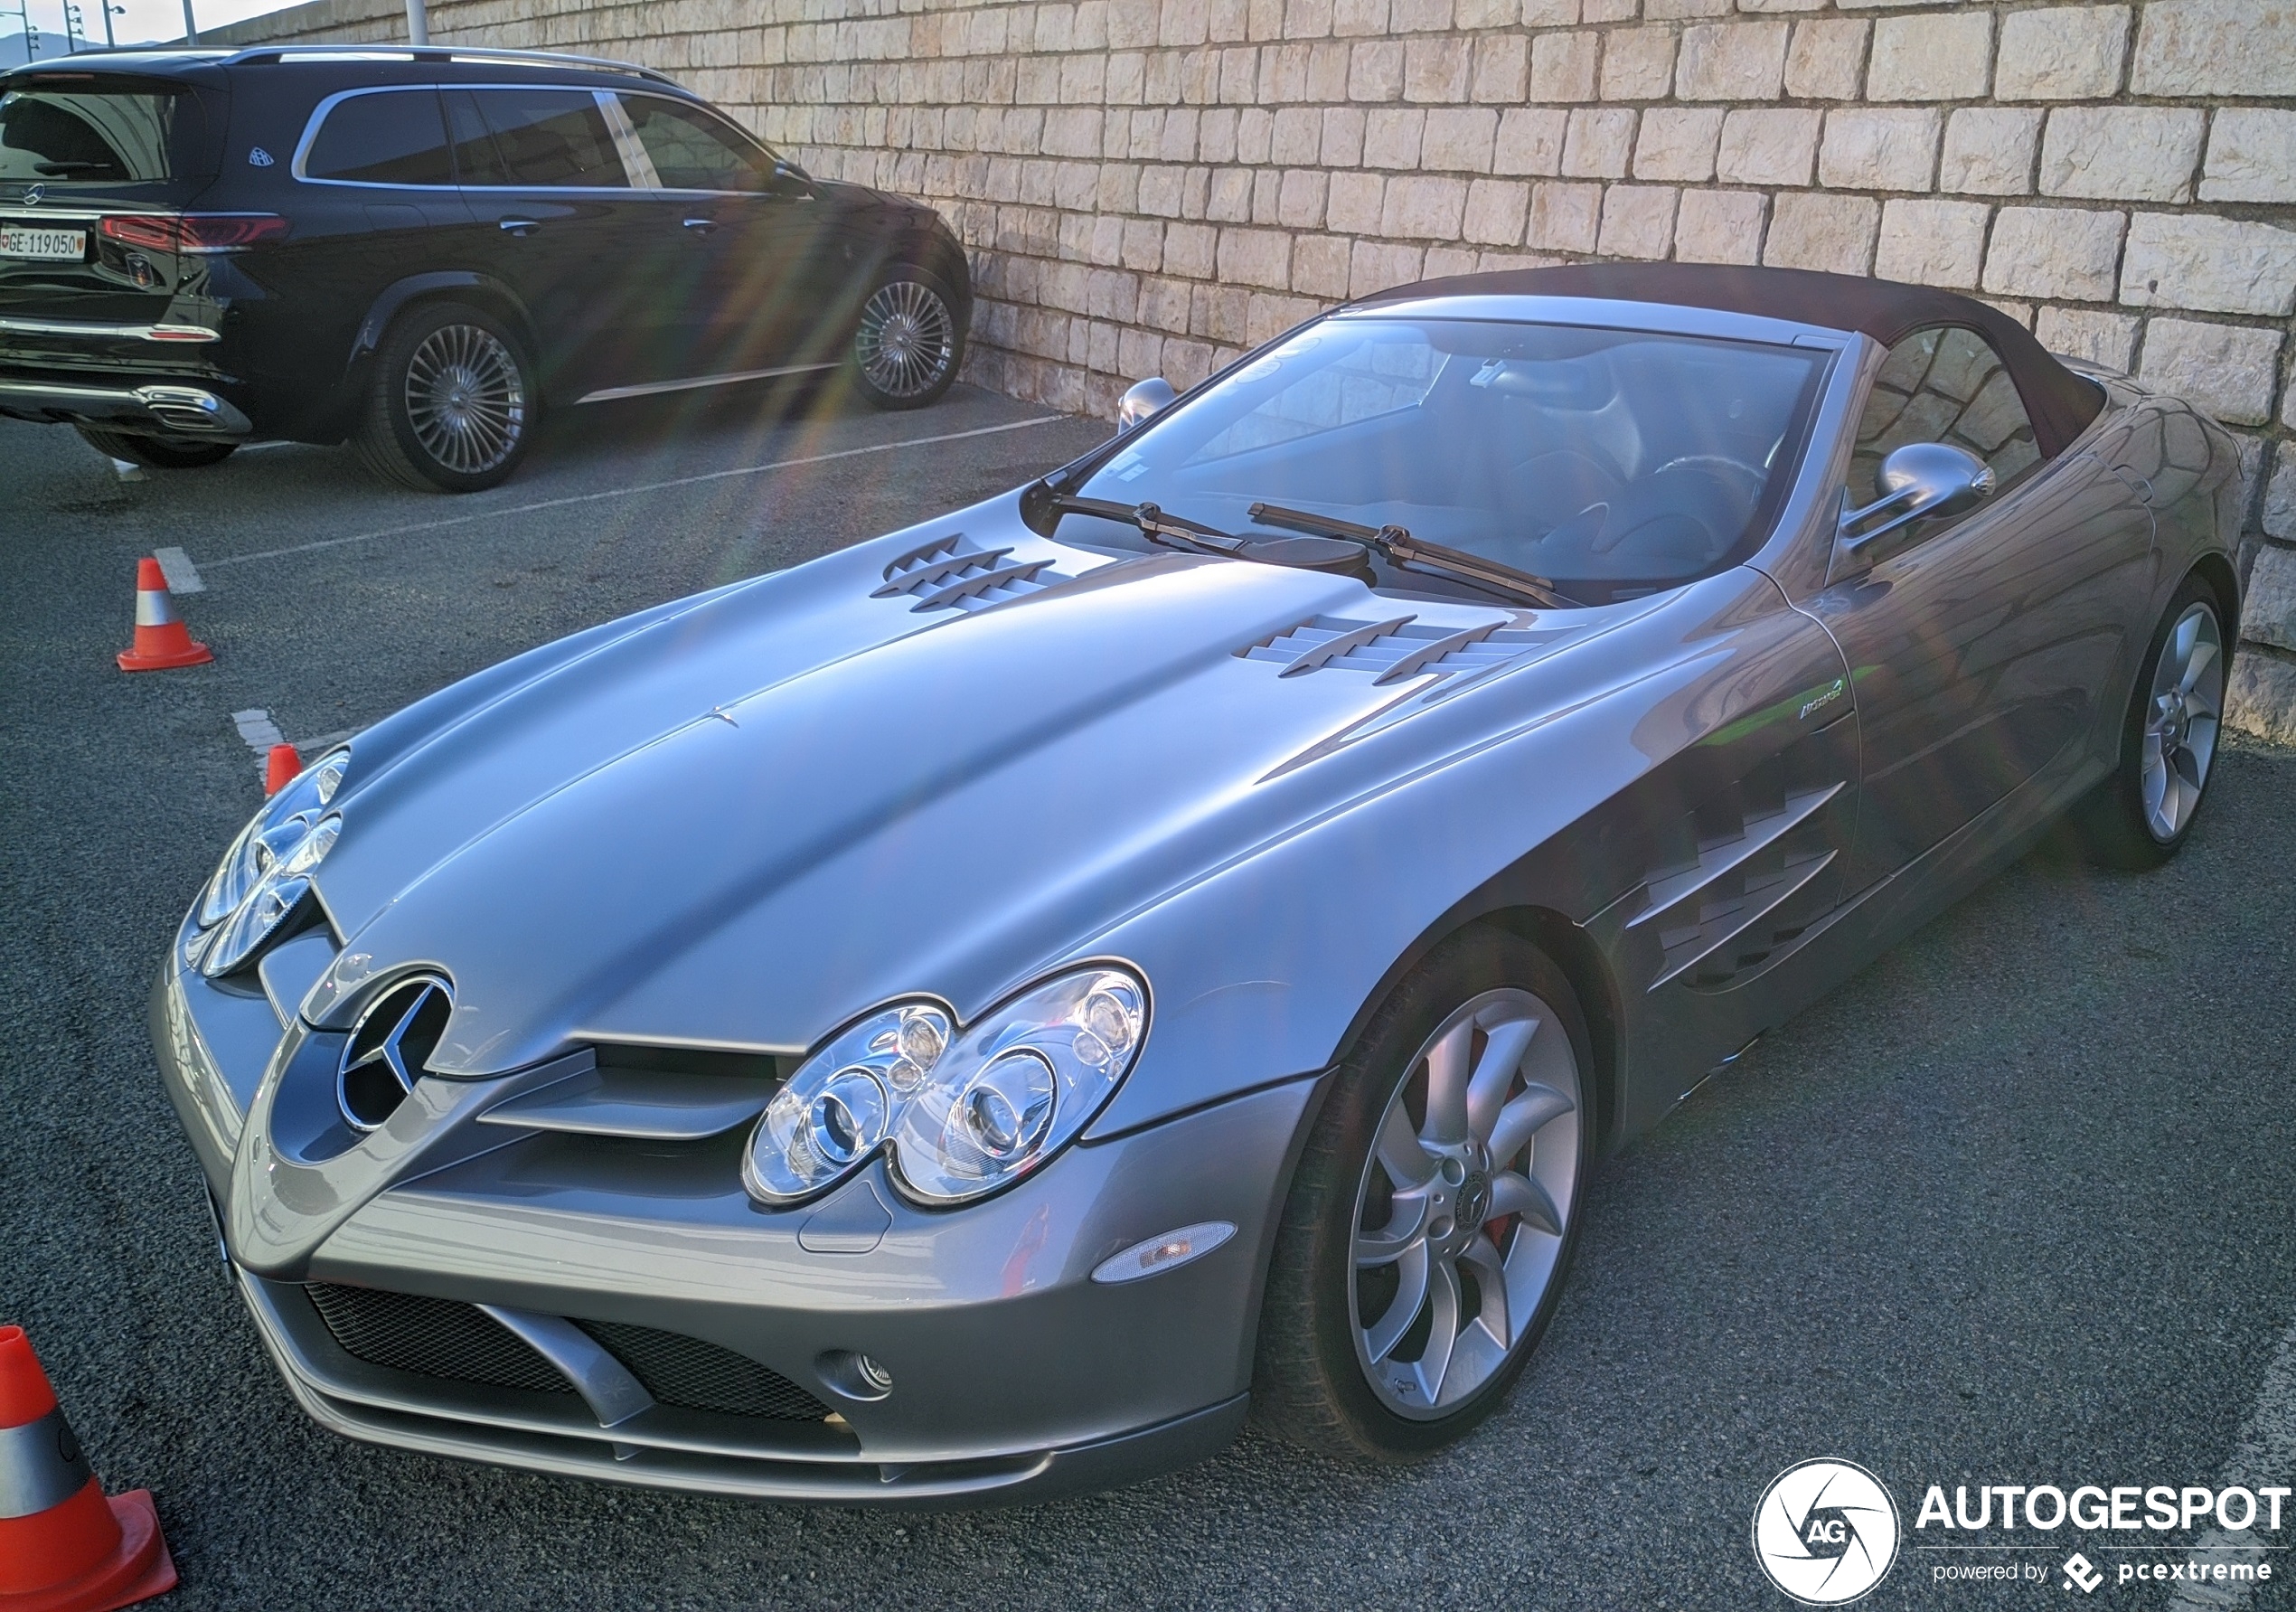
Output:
[{"xmin": 741, "ymin": 965, "xmax": 1148, "ymax": 1203}]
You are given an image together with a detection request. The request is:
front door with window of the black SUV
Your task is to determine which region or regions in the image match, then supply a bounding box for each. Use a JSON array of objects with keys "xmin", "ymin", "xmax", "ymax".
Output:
[{"xmin": 620, "ymin": 92, "xmax": 836, "ymax": 377}]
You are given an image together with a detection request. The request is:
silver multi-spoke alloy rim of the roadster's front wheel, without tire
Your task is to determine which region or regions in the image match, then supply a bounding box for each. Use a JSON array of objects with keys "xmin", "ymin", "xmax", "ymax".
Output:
[{"xmin": 1348, "ymin": 987, "xmax": 1580, "ymax": 1419}]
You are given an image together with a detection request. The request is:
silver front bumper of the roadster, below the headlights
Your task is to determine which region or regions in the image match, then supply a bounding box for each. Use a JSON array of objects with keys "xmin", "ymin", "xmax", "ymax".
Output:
[{"xmin": 152, "ymin": 946, "xmax": 1315, "ymax": 1504}]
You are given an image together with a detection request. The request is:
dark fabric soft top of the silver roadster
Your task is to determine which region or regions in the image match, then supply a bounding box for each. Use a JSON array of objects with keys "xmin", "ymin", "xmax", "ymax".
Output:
[{"xmin": 1361, "ymin": 264, "xmax": 2105, "ymax": 459}]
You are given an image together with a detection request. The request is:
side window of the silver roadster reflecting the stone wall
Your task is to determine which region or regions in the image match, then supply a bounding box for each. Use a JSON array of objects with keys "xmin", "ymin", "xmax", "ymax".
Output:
[{"xmin": 1850, "ymin": 326, "xmax": 2041, "ymax": 503}]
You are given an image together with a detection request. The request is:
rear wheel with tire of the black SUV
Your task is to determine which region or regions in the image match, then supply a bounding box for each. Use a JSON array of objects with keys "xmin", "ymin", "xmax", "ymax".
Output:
[{"xmin": 352, "ymin": 303, "xmax": 535, "ymax": 494}]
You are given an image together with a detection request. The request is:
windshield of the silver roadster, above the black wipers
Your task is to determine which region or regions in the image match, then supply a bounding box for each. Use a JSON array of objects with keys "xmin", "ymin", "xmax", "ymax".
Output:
[{"xmin": 1077, "ymin": 317, "xmax": 1828, "ymax": 601}]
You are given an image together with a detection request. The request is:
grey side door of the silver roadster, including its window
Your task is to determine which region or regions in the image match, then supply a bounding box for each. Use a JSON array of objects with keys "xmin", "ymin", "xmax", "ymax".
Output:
[{"xmin": 1804, "ymin": 326, "xmax": 2151, "ymax": 891}]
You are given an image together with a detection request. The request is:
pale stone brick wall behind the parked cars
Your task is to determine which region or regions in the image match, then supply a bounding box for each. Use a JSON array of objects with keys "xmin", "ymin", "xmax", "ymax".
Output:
[{"xmin": 222, "ymin": 0, "xmax": 2296, "ymax": 741}]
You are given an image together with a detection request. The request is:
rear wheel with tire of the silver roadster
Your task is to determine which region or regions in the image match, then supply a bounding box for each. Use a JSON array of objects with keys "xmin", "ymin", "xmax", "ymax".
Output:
[{"xmin": 2069, "ymin": 577, "xmax": 2227, "ymax": 872}]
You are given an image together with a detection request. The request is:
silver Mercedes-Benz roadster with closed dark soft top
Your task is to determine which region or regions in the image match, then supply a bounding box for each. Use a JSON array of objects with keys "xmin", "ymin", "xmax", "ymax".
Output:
[{"xmin": 152, "ymin": 267, "xmax": 2239, "ymax": 1504}]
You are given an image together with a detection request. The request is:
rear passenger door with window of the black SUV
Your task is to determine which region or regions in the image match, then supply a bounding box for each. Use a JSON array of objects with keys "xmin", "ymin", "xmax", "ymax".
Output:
[{"xmin": 446, "ymin": 85, "xmax": 663, "ymax": 400}]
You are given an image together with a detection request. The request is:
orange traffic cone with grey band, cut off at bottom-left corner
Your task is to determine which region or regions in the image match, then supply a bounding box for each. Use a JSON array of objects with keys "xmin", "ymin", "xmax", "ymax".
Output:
[{"xmin": 0, "ymin": 1327, "xmax": 174, "ymax": 1612}]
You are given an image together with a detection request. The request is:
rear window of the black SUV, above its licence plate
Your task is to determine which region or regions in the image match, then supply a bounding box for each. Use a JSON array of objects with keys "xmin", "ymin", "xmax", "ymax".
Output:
[{"xmin": 0, "ymin": 73, "xmax": 207, "ymax": 184}]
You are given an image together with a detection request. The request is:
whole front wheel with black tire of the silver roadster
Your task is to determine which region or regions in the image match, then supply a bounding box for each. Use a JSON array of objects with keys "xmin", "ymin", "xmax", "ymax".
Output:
[{"xmin": 1254, "ymin": 928, "xmax": 1594, "ymax": 1463}]
